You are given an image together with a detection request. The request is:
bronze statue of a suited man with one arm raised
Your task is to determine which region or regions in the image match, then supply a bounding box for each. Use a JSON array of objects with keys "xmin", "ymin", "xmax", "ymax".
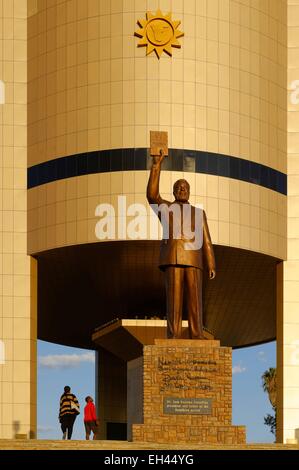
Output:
[{"xmin": 147, "ymin": 152, "xmax": 216, "ymax": 339}]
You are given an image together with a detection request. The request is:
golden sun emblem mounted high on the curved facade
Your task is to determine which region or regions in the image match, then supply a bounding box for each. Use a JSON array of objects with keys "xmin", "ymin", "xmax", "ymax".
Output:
[{"xmin": 135, "ymin": 10, "xmax": 184, "ymax": 59}]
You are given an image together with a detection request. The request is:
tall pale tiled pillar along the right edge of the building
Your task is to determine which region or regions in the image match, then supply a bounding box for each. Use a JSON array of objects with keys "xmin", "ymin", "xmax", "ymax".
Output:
[{"xmin": 277, "ymin": 0, "xmax": 299, "ymax": 442}]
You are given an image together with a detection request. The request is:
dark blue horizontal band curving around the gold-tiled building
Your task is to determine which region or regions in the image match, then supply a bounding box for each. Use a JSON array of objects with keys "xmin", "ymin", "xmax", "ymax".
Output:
[{"xmin": 28, "ymin": 148, "xmax": 287, "ymax": 195}]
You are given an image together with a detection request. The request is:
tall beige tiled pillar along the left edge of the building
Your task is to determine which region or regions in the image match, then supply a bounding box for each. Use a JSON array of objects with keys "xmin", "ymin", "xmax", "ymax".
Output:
[{"xmin": 0, "ymin": 0, "xmax": 37, "ymax": 438}]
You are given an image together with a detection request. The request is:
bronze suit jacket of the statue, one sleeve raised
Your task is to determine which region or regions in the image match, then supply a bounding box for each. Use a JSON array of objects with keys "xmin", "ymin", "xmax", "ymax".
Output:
[{"xmin": 147, "ymin": 166, "xmax": 215, "ymax": 270}]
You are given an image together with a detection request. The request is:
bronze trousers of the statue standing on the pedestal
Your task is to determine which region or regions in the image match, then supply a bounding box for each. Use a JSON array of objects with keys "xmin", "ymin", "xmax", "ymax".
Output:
[{"xmin": 165, "ymin": 266, "xmax": 204, "ymax": 339}]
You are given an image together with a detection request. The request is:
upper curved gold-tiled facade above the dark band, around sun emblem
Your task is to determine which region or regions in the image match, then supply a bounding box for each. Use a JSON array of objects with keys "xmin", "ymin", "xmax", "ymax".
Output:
[{"xmin": 28, "ymin": 0, "xmax": 287, "ymax": 171}]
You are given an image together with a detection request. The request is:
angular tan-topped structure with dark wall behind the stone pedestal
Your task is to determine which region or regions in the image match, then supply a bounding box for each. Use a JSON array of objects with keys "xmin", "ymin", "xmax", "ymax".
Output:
[{"xmin": 92, "ymin": 319, "xmax": 214, "ymax": 440}]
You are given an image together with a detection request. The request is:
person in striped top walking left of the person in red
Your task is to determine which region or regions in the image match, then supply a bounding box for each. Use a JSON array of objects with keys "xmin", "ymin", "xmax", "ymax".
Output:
[{"xmin": 59, "ymin": 385, "xmax": 80, "ymax": 439}]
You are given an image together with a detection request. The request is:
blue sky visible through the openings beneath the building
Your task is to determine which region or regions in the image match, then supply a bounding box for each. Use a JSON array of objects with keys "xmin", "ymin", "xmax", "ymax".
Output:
[{"xmin": 38, "ymin": 341, "xmax": 276, "ymax": 442}]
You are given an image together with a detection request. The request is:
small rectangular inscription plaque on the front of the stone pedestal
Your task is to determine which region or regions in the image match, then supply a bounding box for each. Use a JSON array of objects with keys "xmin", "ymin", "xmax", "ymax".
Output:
[{"xmin": 163, "ymin": 397, "xmax": 212, "ymax": 415}]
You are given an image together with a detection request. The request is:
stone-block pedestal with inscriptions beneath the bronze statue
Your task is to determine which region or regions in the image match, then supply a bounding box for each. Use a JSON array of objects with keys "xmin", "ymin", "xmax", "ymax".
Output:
[{"xmin": 132, "ymin": 340, "xmax": 246, "ymax": 444}]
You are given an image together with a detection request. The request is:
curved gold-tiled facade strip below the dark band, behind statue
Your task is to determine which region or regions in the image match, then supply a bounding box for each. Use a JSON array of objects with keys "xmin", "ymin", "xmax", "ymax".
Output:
[{"xmin": 28, "ymin": 171, "xmax": 287, "ymax": 259}]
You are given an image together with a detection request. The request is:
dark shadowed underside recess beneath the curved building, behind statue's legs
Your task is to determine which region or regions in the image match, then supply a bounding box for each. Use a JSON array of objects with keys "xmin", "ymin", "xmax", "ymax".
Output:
[{"xmin": 37, "ymin": 241, "xmax": 279, "ymax": 348}]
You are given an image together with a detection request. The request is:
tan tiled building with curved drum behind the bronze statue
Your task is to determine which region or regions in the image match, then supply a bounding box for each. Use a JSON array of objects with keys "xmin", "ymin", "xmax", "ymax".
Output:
[{"xmin": 0, "ymin": 0, "xmax": 299, "ymax": 440}]
